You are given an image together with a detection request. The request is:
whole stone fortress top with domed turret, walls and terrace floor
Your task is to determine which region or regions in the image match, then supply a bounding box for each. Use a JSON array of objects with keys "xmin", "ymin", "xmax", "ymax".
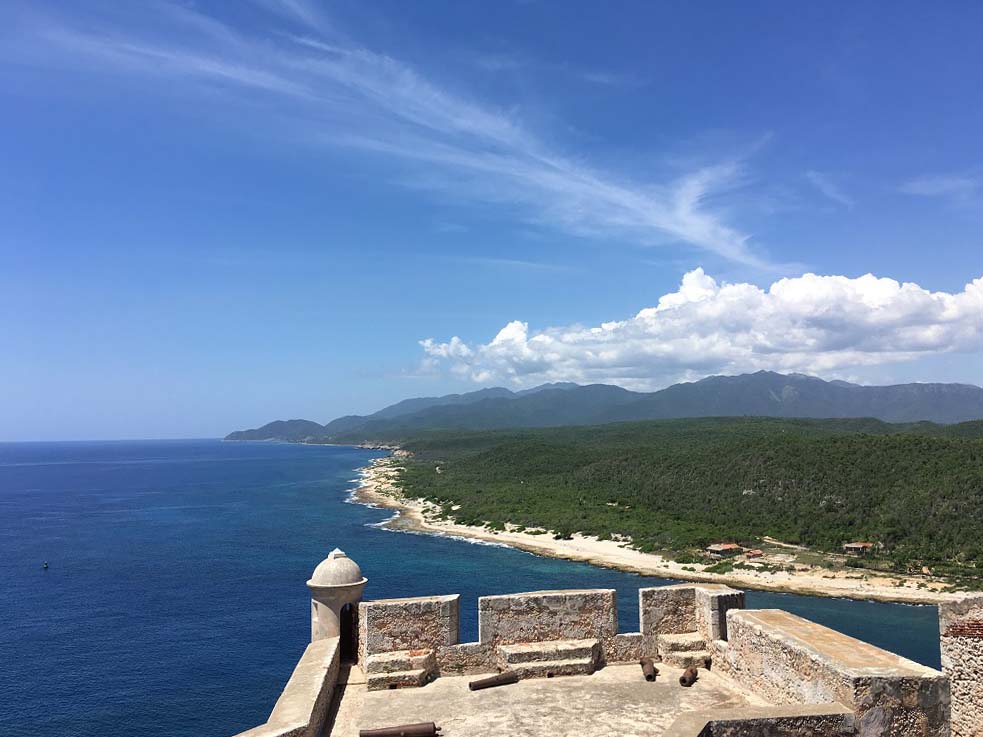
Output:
[{"xmin": 233, "ymin": 551, "xmax": 983, "ymax": 737}]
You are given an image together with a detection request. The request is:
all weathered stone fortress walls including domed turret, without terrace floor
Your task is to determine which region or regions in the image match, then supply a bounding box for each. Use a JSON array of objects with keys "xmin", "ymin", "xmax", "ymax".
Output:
[{"xmin": 233, "ymin": 551, "xmax": 983, "ymax": 737}]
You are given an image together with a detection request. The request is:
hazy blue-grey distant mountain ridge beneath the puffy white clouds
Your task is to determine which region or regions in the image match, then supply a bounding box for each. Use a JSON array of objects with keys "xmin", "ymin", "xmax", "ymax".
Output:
[{"xmin": 226, "ymin": 371, "xmax": 983, "ymax": 443}]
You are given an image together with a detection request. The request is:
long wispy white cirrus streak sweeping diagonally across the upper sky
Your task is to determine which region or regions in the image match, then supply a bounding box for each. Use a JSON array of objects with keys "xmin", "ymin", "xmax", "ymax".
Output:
[{"xmin": 4, "ymin": 0, "xmax": 773, "ymax": 269}]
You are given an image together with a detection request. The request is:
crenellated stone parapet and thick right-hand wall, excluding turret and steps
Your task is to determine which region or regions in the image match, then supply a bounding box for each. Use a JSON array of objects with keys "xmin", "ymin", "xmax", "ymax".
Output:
[{"xmin": 360, "ymin": 584, "xmax": 952, "ymax": 737}]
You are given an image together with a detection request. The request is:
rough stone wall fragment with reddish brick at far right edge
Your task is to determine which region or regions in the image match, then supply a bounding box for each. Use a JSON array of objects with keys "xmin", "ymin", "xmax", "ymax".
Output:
[{"xmin": 939, "ymin": 594, "xmax": 983, "ymax": 737}]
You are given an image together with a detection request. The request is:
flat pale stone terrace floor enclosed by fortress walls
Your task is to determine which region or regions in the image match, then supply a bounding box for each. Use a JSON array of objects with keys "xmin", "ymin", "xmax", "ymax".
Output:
[{"xmin": 325, "ymin": 663, "xmax": 764, "ymax": 737}]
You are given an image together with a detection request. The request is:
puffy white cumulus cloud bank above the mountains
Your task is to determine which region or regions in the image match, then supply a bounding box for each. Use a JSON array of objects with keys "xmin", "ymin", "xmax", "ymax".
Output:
[{"xmin": 420, "ymin": 268, "xmax": 983, "ymax": 389}]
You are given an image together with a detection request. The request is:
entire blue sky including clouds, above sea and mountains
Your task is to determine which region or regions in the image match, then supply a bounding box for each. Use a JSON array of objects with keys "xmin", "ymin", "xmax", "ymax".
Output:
[{"xmin": 0, "ymin": 0, "xmax": 983, "ymax": 440}]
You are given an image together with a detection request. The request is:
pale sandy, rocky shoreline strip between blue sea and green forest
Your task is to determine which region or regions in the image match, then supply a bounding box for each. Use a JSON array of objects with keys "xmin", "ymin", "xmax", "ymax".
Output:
[{"xmin": 351, "ymin": 450, "xmax": 958, "ymax": 605}]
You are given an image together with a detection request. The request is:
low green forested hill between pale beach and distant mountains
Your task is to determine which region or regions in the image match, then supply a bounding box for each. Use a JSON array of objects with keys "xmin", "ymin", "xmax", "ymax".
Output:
[{"xmin": 403, "ymin": 418, "xmax": 983, "ymax": 567}]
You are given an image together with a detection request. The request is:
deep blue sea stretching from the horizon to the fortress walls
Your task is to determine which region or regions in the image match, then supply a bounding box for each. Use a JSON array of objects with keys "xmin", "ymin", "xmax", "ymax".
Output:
[{"xmin": 0, "ymin": 440, "xmax": 939, "ymax": 737}]
